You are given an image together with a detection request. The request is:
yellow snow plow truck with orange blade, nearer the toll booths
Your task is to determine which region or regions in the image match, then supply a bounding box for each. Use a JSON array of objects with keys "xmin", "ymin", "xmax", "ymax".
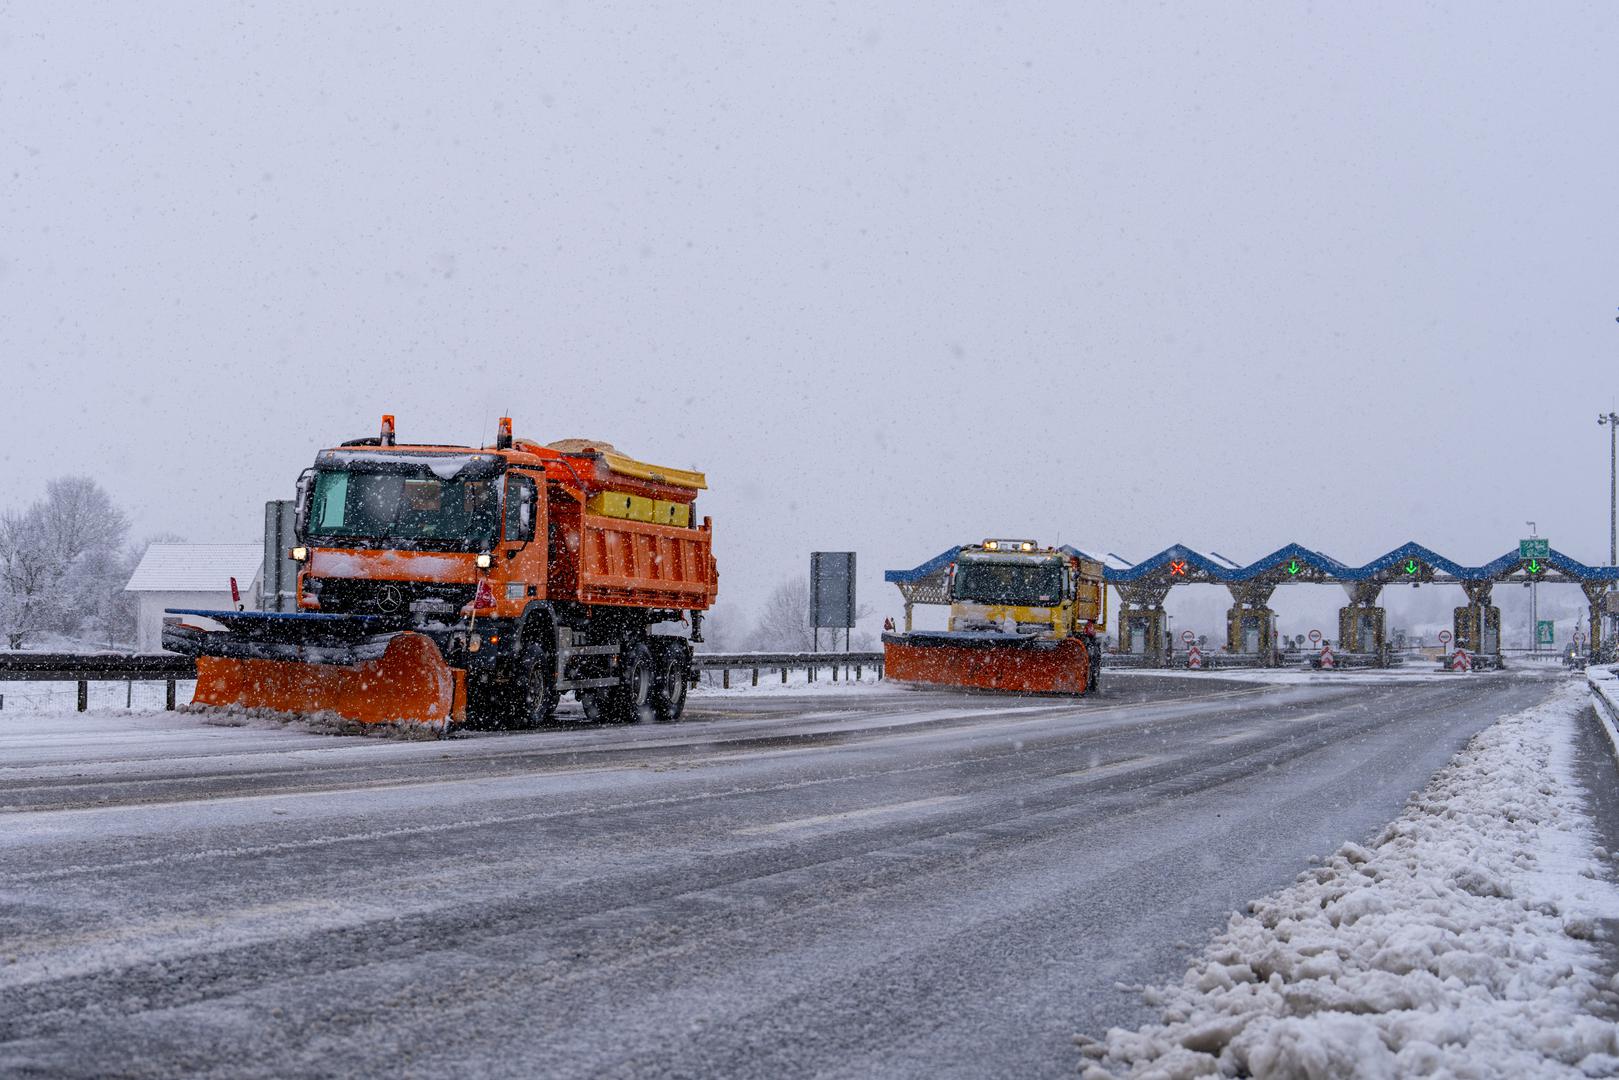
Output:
[{"xmin": 882, "ymin": 539, "xmax": 1107, "ymax": 695}]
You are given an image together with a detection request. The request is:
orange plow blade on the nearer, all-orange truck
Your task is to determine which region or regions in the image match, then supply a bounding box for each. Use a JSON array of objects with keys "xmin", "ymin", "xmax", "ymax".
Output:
[{"xmin": 191, "ymin": 633, "xmax": 466, "ymax": 729}]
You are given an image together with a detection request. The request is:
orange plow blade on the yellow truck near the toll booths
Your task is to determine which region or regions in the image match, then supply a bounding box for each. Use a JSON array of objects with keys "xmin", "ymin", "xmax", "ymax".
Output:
[{"xmin": 882, "ymin": 631, "xmax": 1091, "ymax": 695}]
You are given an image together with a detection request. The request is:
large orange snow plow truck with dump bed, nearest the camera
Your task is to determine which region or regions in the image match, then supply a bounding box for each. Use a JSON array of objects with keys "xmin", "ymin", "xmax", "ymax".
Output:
[{"xmin": 164, "ymin": 416, "xmax": 719, "ymax": 730}]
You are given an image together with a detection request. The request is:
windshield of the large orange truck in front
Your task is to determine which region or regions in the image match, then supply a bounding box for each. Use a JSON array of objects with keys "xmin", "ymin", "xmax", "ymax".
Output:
[{"xmin": 308, "ymin": 468, "xmax": 500, "ymax": 551}]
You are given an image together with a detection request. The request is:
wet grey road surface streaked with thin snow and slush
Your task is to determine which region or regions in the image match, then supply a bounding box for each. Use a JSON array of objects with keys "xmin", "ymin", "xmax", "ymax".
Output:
[{"xmin": 0, "ymin": 674, "xmax": 1566, "ymax": 1077}]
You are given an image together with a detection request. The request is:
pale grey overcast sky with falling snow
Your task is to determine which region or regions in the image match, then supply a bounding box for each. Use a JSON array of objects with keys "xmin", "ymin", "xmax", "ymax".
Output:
[{"xmin": 0, "ymin": 0, "xmax": 1619, "ymax": 637}]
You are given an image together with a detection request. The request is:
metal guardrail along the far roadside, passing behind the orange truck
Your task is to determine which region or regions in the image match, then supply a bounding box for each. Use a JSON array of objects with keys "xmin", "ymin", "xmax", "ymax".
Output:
[{"xmin": 0, "ymin": 653, "xmax": 882, "ymax": 712}]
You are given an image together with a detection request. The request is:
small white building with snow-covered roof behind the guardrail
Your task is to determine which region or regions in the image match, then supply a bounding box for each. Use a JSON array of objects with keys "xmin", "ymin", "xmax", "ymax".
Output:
[{"xmin": 123, "ymin": 544, "xmax": 264, "ymax": 653}]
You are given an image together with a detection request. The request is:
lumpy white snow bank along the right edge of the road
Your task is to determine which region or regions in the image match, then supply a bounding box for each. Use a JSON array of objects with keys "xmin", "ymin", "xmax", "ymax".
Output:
[{"xmin": 1077, "ymin": 683, "xmax": 1619, "ymax": 1080}]
